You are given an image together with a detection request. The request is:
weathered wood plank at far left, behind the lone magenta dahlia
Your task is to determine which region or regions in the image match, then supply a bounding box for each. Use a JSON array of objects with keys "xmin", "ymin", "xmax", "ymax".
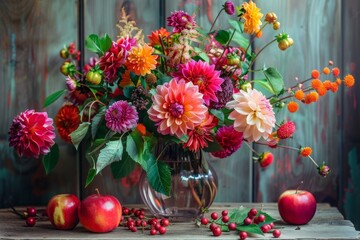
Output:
[{"xmin": 0, "ymin": 0, "xmax": 77, "ymax": 207}]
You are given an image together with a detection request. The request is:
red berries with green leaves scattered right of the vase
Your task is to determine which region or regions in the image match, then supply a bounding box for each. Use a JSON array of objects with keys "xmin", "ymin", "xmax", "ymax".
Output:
[{"xmin": 198, "ymin": 208, "xmax": 281, "ymax": 240}]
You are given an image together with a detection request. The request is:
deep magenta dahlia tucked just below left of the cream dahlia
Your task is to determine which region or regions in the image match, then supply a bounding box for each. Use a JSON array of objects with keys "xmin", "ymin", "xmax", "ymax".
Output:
[{"xmin": 211, "ymin": 126, "xmax": 243, "ymax": 158}]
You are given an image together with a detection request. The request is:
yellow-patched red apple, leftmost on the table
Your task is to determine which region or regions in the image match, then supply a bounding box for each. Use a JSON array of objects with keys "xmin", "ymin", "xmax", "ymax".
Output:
[{"xmin": 46, "ymin": 194, "xmax": 80, "ymax": 230}]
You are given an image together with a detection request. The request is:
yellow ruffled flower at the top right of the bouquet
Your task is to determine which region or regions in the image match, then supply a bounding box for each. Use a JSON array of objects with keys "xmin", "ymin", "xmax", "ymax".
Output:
[{"xmin": 242, "ymin": 1, "xmax": 263, "ymax": 34}]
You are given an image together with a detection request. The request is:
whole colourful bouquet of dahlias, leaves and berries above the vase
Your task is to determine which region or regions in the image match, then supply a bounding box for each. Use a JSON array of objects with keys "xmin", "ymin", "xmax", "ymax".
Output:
[{"xmin": 9, "ymin": 0, "xmax": 355, "ymax": 194}]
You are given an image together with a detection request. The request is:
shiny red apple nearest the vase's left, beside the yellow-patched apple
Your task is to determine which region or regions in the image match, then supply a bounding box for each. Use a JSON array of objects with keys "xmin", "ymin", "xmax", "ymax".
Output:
[{"xmin": 78, "ymin": 194, "xmax": 122, "ymax": 233}]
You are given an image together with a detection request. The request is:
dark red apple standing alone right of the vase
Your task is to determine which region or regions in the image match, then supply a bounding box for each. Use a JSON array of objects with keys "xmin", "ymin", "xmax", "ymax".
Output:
[{"xmin": 278, "ymin": 190, "xmax": 316, "ymax": 225}]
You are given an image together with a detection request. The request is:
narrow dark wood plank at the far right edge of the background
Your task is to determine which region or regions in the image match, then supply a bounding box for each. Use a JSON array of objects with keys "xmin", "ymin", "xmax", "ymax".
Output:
[{"xmin": 339, "ymin": 0, "xmax": 360, "ymax": 230}]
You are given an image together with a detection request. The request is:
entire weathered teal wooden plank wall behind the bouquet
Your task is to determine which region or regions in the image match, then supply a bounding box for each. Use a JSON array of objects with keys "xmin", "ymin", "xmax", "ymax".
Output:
[{"xmin": 0, "ymin": 0, "xmax": 360, "ymax": 231}]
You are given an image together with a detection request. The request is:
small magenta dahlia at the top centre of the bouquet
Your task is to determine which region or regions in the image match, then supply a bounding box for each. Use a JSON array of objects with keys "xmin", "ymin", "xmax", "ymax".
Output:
[{"xmin": 167, "ymin": 11, "xmax": 196, "ymax": 33}]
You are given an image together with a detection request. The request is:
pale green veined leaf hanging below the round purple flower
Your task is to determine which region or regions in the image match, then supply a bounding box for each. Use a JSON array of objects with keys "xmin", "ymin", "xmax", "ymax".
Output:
[{"xmin": 96, "ymin": 140, "xmax": 123, "ymax": 174}]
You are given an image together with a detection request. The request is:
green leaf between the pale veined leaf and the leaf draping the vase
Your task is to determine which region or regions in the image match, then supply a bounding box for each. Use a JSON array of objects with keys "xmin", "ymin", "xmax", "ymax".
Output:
[{"xmin": 126, "ymin": 131, "xmax": 147, "ymax": 170}]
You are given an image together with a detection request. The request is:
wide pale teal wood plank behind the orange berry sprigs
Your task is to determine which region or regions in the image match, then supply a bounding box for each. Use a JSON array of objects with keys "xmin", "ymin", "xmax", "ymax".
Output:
[{"xmin": 254, "ymin": 0, "xmax": 342, "ymax": 204}]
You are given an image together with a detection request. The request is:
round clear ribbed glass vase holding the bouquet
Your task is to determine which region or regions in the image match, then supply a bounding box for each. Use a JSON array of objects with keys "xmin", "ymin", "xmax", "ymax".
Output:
[{"xmin": 139, "ymin": 143, "xmax": 218, "ymax": 221}]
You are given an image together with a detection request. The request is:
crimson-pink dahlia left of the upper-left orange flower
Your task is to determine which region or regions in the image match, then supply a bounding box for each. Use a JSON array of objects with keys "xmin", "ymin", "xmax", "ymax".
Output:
[{"xmin": 99, "ymin": 37, "xmax": 136, "ymax": 83}]
